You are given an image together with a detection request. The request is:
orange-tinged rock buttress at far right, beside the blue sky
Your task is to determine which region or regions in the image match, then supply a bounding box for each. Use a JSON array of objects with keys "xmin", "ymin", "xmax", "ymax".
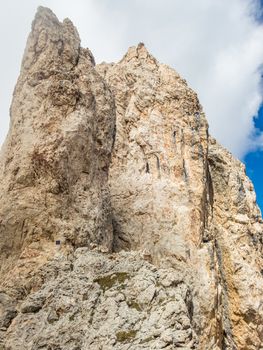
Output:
[{"xmin": 209, "ymin": 139, "xmax": 263, "ymax": 350}]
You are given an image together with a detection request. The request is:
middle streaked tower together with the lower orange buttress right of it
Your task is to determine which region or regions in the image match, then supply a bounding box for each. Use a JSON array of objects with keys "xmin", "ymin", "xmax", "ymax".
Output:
[{"xmin": 97, "ymin": 44, "xmax": 263, "ymax": 349}]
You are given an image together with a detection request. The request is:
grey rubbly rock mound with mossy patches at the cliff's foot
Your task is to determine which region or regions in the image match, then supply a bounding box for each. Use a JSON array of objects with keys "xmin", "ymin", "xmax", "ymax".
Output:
[{"xmin": 4, "ymin": 248, "xmax": 197, "ymax": 350}]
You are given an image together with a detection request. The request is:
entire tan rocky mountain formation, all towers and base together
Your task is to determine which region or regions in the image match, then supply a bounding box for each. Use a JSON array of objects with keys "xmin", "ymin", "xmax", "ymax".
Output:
[{"xmin": 0, "ymin": 8, "xmax": 263, "ymax": 350}]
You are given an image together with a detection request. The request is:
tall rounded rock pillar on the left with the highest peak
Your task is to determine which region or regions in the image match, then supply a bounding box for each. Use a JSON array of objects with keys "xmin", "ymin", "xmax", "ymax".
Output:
[{"xmin": 0, "ymin": 8, "xmax": 115, "ymax": 271}]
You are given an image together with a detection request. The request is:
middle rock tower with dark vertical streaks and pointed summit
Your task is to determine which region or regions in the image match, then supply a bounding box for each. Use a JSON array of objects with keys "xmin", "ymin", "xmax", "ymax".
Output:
[{"xmin": 97, "ymin": 44, "xmax": 221, "ymax": 349}]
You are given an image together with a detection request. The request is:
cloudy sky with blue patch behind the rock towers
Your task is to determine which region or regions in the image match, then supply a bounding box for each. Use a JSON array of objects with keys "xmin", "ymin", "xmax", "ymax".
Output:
[{"xmin": 0, "ymin": 0, "xmax": 263, "ymax": 208}]
